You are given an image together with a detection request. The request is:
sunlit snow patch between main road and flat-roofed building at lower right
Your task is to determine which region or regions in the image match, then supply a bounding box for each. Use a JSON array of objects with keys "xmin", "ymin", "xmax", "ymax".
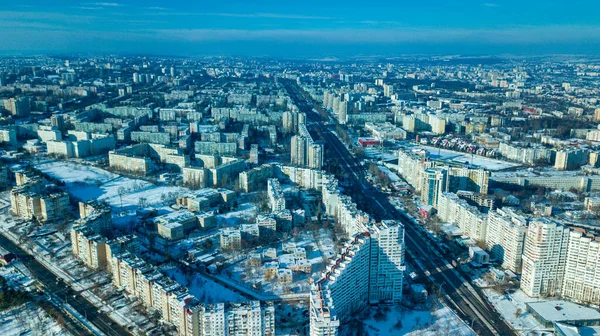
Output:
[{"xmin": 483, "ymin": 288, "xmax": 549, "ymax": 335}]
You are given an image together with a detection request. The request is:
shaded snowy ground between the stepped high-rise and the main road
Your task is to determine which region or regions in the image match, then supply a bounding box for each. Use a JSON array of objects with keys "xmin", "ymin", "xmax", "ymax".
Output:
[{"xmin": 364, "ymin": 305, "xmax": 475, "ymax": 336}]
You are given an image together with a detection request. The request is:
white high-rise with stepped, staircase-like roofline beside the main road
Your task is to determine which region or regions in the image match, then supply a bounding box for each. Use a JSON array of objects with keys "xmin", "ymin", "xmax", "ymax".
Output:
[{"xmin": 310, "ymin": 221, "xmax": 404, "ymax": 336}]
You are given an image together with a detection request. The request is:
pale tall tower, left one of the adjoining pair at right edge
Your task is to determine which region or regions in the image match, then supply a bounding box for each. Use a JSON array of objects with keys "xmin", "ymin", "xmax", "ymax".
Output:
[{"xmin": 521, "ymin": 218, "xmax": 569, "ymax": 297}]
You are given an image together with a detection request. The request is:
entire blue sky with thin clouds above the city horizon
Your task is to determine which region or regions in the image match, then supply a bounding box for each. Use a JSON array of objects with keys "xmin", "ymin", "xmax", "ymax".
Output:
[{"xmin": 0, "ymin": 0, "xmax": 600, "ymax": 57}]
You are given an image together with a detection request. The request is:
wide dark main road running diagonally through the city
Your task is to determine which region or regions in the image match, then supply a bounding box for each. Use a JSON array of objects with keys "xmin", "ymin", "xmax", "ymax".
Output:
[{"xmin": 282, "ymin": 80, "xmax": 514, "ymax": 335}]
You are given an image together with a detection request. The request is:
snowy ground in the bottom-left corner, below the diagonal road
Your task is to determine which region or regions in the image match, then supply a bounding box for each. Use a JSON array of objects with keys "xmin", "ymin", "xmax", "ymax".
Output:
[{"xmin": 0, "ymin": 302, "xmax": 71, "ymax": 336}]
